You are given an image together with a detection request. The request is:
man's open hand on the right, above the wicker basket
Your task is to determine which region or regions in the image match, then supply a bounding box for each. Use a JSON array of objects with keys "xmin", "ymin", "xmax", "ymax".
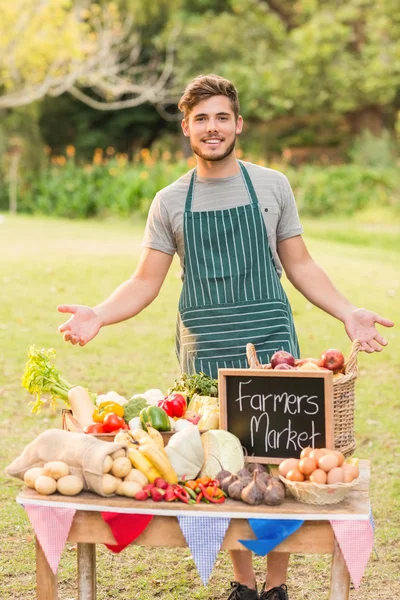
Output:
[{"xmin": 344, "ymin": 308, "xmax": 394, "ymax": 352}]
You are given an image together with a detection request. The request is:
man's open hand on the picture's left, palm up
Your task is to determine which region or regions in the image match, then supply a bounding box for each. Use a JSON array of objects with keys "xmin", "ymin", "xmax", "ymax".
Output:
[{"xmin": 57, "ymin": 304, "xmax": 102, "ymax": 346}]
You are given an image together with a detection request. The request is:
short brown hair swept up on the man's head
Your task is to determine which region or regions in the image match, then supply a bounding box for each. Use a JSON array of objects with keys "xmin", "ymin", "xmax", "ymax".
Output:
[{"xmin": 178, "ymin": 73, "xmax": 240, "ymax": 119}]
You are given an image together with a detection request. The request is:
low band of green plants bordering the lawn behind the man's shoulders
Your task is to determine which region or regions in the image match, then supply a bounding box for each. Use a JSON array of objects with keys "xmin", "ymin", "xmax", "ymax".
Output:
[{"xmin": 7, "ymin": 157, "xmax": 400, "ymax": 219}]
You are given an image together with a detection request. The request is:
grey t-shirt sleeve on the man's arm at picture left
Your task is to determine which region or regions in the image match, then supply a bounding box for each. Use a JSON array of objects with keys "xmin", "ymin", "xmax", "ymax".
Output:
[{"xmin": 142, "ymin": 193, "xmax": 176, "ymax": 255}]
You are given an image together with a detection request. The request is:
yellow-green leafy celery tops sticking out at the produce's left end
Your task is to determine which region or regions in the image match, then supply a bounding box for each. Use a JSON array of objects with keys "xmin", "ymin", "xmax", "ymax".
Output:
[{"xmin": 22, "ymin": 346, "xmax": 73, "ymax": 413}]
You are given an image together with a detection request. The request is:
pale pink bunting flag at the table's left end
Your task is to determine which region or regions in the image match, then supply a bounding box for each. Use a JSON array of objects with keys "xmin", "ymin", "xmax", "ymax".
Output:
[{"xmin": 24, "ymin": 504, "xmax": 76, "ymax": 575}]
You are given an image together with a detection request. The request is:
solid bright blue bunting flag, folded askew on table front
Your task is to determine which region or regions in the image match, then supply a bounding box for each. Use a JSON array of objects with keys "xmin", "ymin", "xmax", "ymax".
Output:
[{"xmin": 239, "ymin": 519, "xmax": 304, "ymax": 556}]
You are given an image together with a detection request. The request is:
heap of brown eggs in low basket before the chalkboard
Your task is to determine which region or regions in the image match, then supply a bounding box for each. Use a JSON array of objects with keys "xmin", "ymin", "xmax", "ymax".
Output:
[{"xmin": 279, "ymin": 447, "xmax": 359, "ymax": 485}]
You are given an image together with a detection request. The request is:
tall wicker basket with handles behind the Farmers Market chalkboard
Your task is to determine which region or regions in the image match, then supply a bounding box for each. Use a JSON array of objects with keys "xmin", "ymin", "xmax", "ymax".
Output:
[{"xmin": 246, "ymin": 340, "xmax": 361, "ymax": 454}]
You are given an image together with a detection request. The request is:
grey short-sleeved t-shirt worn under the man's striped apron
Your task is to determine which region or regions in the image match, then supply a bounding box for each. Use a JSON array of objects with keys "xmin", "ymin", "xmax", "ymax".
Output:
[{"xmin": 142, "ymin": 162, "xmax": 303, "ymax": 276}]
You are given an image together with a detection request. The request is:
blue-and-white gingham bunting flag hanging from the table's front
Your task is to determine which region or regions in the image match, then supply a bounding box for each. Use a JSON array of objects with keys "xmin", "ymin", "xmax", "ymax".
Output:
[{"xmin": 177, "ymin": 516, "xmax": 230, "ymax": 585}]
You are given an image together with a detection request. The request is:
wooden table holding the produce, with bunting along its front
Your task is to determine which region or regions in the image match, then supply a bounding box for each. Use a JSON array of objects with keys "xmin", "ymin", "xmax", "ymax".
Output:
[{"xmin": 17, "ymin": 460, "xmax": 370, "ymax": 600}]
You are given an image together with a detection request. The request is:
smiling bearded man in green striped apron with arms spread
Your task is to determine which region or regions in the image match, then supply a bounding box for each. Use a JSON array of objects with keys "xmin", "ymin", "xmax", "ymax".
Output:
[{"xmin": 58, "ymin": 75, "xmax": 393, "ymax": 600}]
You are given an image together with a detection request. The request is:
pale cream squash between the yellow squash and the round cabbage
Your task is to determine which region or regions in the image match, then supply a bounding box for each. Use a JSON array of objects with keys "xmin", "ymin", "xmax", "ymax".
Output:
[{"xmin": 165, "ymin": 425, "xmax": 204, "ymax": 480}]
